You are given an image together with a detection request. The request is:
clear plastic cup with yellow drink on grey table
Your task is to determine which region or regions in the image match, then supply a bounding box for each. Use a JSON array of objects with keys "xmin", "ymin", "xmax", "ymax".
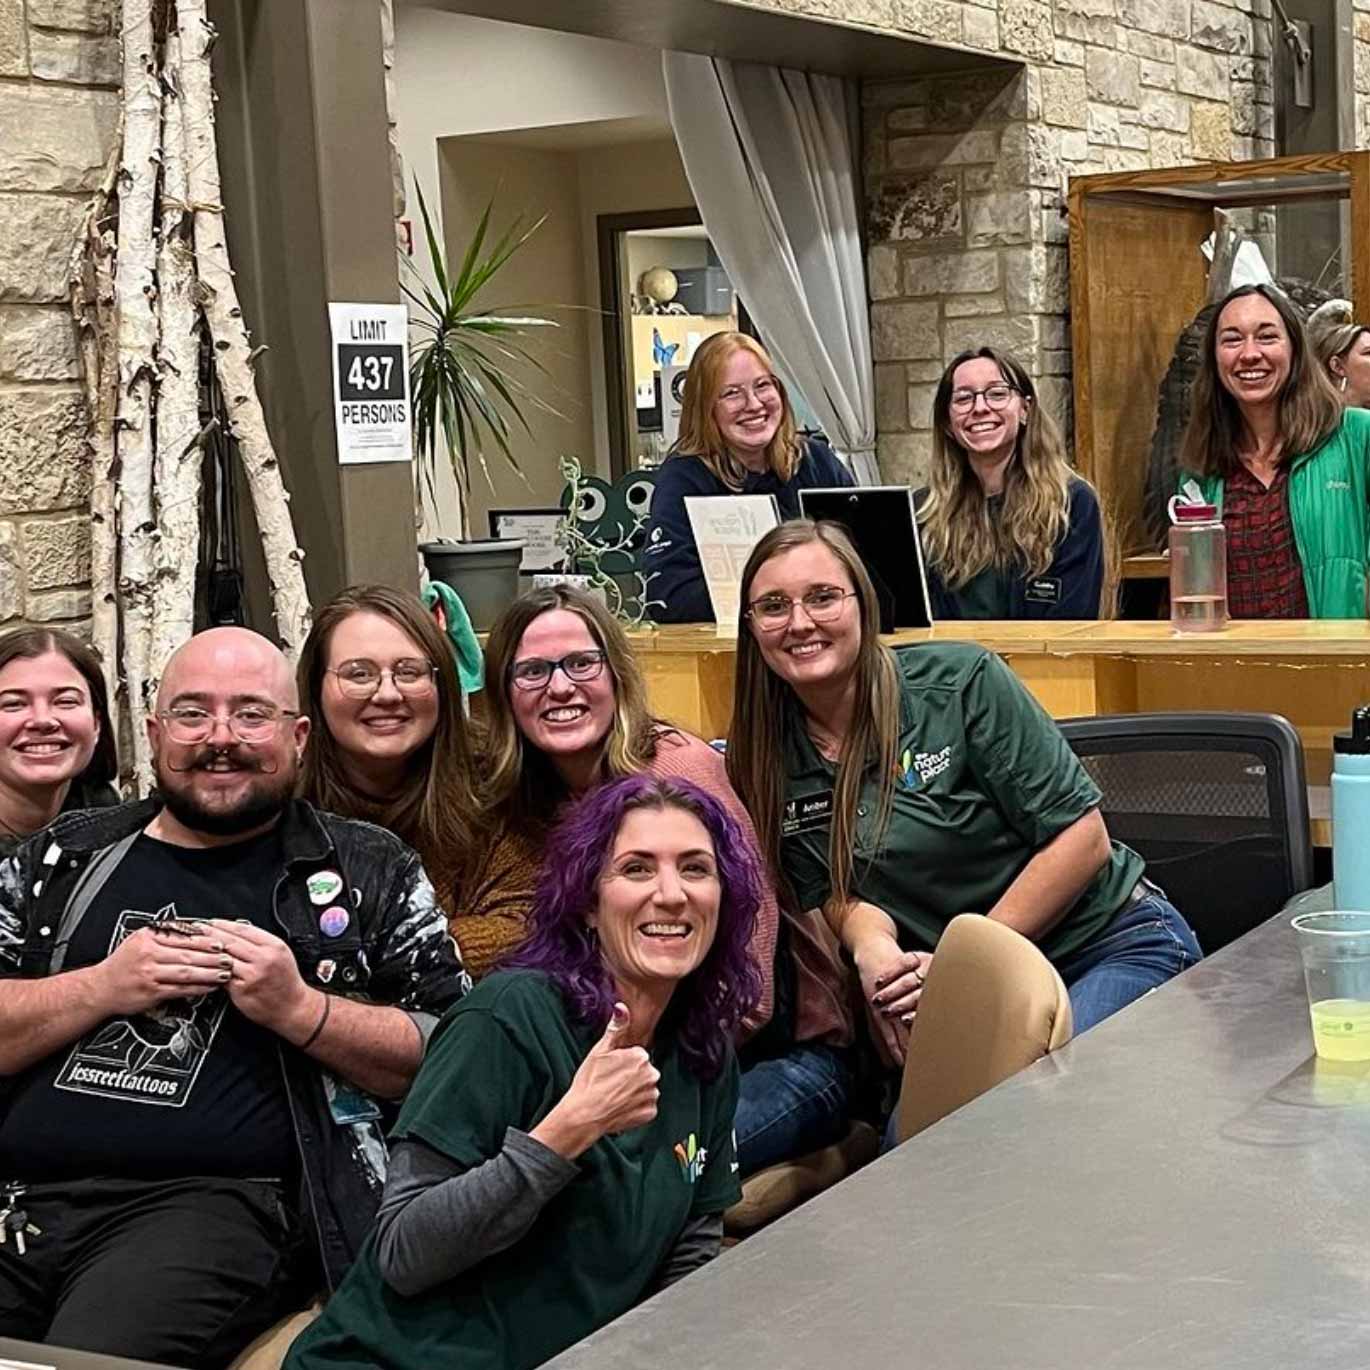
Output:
[{"xmin": 1292, "ymin": 912, "xmax": 1370, "ymax": 1060}]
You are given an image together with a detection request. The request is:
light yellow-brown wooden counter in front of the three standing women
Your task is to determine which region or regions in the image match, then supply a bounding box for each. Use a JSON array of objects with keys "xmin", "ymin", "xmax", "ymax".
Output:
[{"xmin": 629, "ymin": 619, "xmax": 1370, "ymax": 844}]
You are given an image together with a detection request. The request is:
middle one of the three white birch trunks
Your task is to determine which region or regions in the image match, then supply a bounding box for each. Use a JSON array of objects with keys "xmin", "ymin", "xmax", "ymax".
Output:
[{"xmin": 148, "ymin": 33, "xmax": 203, "ymax": 692}]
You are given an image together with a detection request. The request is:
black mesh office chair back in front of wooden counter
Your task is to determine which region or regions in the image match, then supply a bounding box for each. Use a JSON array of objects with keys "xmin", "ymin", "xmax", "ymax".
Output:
[{"xmin": 1060, "ymin": 714, "xmax": 1312, "ymax": 952}]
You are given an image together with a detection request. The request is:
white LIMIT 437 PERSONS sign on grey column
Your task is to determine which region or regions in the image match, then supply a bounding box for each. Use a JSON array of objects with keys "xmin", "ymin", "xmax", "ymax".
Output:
[{"xmin": 329, "ymin": 304, "xmax": 412, "ymax": 463}]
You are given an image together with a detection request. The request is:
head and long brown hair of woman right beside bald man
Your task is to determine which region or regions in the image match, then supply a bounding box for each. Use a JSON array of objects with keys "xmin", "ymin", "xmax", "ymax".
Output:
[{"xmin": 297, "ymin": 585, "xmax": 475, "ymax": 926}]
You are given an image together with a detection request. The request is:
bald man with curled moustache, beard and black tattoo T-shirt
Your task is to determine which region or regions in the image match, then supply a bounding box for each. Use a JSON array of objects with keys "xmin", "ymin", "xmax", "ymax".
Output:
[{"xmin": 0, "ymin": 627, "xmax": 469, "ymax": 1367}]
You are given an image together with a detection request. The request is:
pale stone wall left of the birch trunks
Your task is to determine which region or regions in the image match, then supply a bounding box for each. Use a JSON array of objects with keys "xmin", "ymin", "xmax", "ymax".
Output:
[{"xmin": 0, "ymin": 0, "xmax": 119, "ymax": 629}]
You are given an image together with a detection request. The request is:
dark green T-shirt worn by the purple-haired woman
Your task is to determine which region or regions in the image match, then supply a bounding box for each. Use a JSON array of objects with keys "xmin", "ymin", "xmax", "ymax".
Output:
[{"xmin": 290, "ymin": 970, "xmax": 741, "ymax": 1370}]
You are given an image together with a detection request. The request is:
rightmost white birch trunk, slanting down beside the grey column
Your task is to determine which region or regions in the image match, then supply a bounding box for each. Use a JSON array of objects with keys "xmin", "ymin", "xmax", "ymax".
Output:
[{"xmin": 177, "ymin": 0, "xmax": 310, "ymax": 660}]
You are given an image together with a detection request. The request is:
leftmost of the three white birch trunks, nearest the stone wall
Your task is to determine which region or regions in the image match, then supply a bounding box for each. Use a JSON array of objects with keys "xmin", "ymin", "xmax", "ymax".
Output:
[{"xmin": 115, "ymin": 0, "xmax": 162, "ymax": 792}]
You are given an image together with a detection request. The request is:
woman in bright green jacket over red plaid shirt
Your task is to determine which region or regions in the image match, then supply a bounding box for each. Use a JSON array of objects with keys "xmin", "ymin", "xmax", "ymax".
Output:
[{"xmin": 1180, "ymin": 285, "xmax": 1370, "ymax": 618}]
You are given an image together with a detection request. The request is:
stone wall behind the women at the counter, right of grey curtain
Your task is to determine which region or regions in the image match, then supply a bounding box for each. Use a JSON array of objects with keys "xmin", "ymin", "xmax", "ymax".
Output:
[{"xmin": 749, "ymin": 0, "xmax": 1370, "ymax": 482}]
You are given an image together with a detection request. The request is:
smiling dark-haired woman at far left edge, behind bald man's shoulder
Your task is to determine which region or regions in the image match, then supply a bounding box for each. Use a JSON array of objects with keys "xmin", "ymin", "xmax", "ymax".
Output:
[{"xmin": 0, "ymin": 627, "xmax": 118, "ymax": 856}]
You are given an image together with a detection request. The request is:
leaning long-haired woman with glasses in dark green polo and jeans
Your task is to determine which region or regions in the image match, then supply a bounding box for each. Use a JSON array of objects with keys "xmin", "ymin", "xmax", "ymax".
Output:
[{"xmin": 727, "ymin": 519, "xmax": 1200, "ymax": 1062}]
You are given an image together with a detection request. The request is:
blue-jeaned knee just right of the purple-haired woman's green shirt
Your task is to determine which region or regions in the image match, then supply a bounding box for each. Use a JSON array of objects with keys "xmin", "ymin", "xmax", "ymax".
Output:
[{"xmin": 736, "ymin": 1043, "xmax": 851, "ymax": 1180}]
